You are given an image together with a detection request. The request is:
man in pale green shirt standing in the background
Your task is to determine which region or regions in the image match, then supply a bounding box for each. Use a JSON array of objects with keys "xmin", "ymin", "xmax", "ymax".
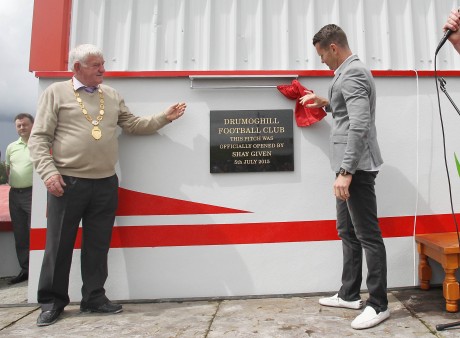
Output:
[{"xmin": 5, "ymin": 113, "xmax": 34, "ymax": 285}]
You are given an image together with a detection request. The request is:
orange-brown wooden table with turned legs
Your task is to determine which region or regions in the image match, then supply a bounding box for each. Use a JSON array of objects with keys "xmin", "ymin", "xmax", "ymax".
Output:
[{"xmin": 415, "ymin": 232, "xmax": 460, "ymax": 312}]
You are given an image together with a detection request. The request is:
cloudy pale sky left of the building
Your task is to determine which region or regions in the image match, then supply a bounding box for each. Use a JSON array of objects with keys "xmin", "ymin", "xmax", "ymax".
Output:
[{"xmin": 0, "ymin": 0, "xmax": 38, "ymax": 157}]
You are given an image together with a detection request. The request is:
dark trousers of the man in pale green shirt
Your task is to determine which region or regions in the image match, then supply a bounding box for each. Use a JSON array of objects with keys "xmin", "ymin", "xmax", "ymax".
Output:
[{"xmin": 9, "ymin": 187, "xmax": 32, "ymax": 273}]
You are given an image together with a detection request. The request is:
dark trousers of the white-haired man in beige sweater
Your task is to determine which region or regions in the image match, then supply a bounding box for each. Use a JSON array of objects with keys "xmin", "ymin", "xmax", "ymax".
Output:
[{"xmin": 37, "ymin": 175, "xmax": 118, "ymax": 311}]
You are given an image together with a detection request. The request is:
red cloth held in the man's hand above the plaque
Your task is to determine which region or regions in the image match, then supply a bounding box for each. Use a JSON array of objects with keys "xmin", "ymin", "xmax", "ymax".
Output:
[{"xmin": 276, "ymin": 80, "xmax": 326, "ymax": 127}]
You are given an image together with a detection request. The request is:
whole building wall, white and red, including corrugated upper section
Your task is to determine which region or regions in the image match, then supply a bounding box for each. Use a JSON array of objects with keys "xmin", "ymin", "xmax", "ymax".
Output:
[{"xmin": 29, "ymin": 0, "xmax": 460, "ymax": 302}]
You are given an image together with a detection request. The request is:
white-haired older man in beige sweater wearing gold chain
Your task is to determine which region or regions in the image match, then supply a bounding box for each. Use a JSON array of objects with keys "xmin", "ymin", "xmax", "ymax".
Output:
[{"xmin": 29, "ymin": 44, "xmax": 186, "ymax": 326}]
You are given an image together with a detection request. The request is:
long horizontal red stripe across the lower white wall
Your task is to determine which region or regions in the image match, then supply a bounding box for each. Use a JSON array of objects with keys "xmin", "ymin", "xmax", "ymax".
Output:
[{"xmin": 30, "ymin": 214, "xmax": 455, "ymax": 250}]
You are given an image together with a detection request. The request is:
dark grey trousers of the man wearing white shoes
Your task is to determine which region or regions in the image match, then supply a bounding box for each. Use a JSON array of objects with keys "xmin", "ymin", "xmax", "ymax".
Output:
[{"xmin": 337, "ymin": 171, "xmax": 388, "ymax": 312}]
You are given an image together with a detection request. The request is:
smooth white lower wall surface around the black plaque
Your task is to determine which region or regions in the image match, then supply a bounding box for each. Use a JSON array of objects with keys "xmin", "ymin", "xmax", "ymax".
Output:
[{"xmin": 29, "ymin": 76, "xmax": 460, "ymax": 302}]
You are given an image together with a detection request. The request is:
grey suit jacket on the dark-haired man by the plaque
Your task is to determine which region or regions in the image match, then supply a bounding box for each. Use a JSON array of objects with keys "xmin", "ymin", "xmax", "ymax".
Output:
[{"xmin": 329, "ymin": 55, "xmax": 383, "ymax": 173}]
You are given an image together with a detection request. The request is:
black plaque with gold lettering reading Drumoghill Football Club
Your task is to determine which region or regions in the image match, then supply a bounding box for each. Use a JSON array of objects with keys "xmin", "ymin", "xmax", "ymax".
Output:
[{"xmin": 210, "ymin": 109, "xmax": 294, "ymax": 173}]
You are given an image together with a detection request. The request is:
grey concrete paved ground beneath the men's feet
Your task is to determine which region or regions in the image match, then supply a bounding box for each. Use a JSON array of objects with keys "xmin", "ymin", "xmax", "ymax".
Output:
[{"xmin": 0, "ymin": 279, "xmax": 460, "ymax": 338}]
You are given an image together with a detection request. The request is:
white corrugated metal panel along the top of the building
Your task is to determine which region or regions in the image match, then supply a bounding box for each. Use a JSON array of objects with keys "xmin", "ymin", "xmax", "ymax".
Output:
[{"xmin": 70, "ymin": 0, "xmax": 460, "ymax": 71}]
